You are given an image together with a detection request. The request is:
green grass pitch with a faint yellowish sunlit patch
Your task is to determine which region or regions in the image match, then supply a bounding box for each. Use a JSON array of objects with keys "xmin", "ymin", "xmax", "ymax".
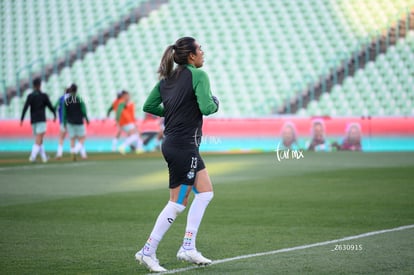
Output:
[{"xmin": 0, "ymin": 152, "xmax": 414, "ymax": 274}]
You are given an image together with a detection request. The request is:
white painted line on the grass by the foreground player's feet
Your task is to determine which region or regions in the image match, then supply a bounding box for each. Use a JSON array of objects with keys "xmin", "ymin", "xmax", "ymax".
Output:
[{"xmin": 158, "ymin": 224, "xmax": 414, "ymax": 274}]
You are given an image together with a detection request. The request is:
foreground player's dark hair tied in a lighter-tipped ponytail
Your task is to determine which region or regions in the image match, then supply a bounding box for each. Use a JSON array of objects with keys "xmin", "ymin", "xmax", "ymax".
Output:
[{"xmin": 158, "ymin": 37, "xmax": 197, "ymax": 79}]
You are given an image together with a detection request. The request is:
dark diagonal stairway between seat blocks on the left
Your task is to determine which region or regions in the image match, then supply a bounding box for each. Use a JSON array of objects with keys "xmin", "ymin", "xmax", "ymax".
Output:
[{"xmin": 0, "ymin": 0, "xmax": 168, "ymax": 105}]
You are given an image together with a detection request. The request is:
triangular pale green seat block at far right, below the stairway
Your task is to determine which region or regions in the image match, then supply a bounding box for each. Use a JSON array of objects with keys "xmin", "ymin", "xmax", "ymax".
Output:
[{"xmin": 297, "ymin": 31, "xmax": 414, "ymax": 117}]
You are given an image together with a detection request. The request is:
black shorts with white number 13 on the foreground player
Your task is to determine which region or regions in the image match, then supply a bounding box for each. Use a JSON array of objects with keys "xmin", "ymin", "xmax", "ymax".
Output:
[{"xmin": 162, "ymin": 139, "xmax": 205, "ymax": 188}]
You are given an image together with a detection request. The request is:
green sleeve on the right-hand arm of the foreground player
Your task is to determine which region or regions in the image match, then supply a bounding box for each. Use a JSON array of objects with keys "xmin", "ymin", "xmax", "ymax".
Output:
[{"xmin": 193, "ymin": 70, "xmax": 219, "ymax": 115}]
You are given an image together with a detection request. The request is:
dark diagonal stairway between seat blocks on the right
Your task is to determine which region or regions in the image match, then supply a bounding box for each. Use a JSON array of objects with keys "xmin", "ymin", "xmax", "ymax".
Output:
[{"xmin": 278, "ymin": 9, "xmax": 414, "ymax": 114}]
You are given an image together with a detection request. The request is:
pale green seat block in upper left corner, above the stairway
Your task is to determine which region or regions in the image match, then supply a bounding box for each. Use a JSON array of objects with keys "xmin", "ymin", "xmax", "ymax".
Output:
[{"xmin": 0, "ymin": 0, "xmax": 144, "ymax": 86}]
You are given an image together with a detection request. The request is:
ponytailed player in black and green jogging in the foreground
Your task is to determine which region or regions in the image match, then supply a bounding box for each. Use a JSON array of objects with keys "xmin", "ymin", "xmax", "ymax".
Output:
[{"xmin": 135, "ymin": 37, "xmax": 219, "ymax": 272}]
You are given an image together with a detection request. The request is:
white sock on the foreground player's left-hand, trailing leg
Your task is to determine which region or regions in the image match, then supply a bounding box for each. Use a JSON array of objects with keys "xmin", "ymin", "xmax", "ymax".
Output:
[{"xmin": 142, "ymin": 201, "xmax": 185, "ymax": 256}]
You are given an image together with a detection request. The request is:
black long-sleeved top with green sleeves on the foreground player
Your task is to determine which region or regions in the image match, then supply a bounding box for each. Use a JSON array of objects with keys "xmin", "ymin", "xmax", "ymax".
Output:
[{"xmin": 143, "ymin": 65, "xmax": 218, "ymax": 144}]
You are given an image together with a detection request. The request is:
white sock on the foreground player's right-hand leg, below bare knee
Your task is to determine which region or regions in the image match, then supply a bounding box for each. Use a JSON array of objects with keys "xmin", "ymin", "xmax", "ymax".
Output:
[{"xmin": 183, "ymin": 192, "xmax": 214, "ymax": 250}]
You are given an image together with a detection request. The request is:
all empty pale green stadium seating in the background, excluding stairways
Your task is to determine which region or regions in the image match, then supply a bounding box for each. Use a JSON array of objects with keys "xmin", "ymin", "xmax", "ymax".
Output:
[{"xmin": 0, "ymin": 0, "xmax": 414, "ymax": 118}]
